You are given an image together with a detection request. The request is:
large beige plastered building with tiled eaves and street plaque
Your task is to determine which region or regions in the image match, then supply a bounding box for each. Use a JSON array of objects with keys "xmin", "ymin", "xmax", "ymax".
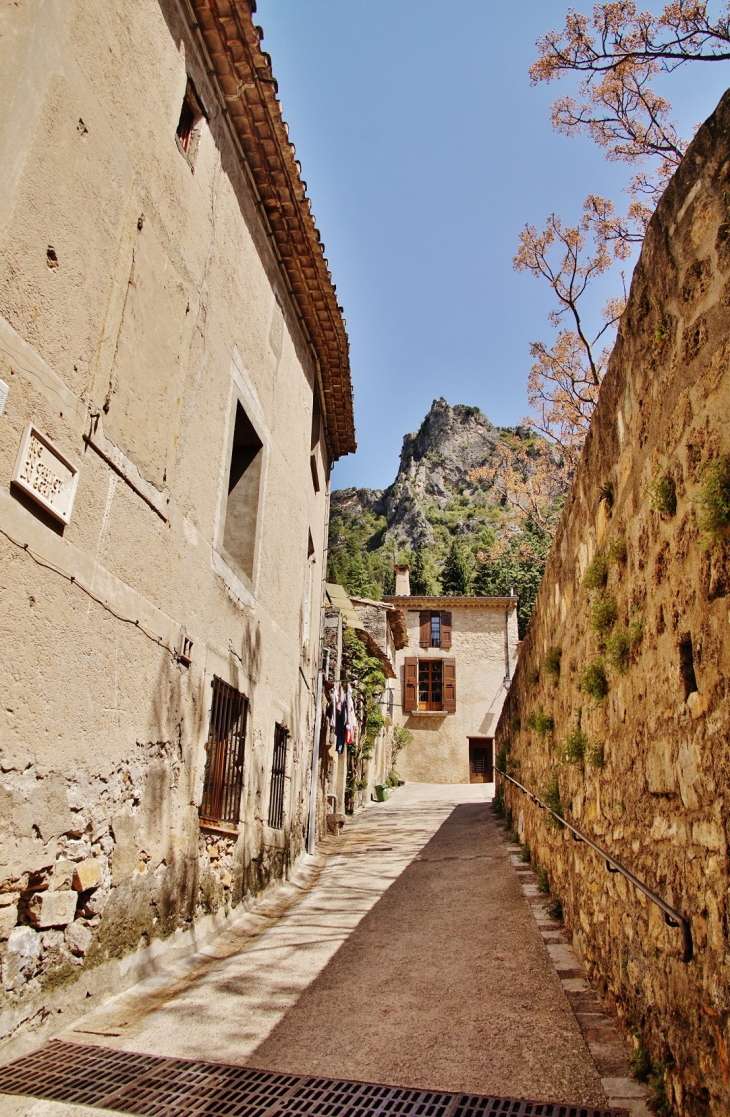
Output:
[{"xmin": 0, "ymin": 0, "xmax": 355, "ymax": 1034}]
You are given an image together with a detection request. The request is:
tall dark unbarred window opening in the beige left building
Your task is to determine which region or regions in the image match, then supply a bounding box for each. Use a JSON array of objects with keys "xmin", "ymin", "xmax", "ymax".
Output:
[{"xmin": 223, "ymin": 403, "xmax": 263, "ymax": 577}]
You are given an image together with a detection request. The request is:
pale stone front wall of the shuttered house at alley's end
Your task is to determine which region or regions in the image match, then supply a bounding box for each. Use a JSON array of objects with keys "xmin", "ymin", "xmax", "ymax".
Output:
[{"xmin": 388, "ymin": 598, "xmax": 517, "ymax": 783}]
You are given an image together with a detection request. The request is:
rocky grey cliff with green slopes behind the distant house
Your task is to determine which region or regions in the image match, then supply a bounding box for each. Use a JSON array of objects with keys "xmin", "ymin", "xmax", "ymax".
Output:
[{"xmin": 329, "ymin": 398, "xmax": 565, "ymax": 623}]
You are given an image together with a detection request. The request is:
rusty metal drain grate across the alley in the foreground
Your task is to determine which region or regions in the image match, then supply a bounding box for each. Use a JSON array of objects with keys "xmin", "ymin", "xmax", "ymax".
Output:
[{"xmin": 0, "ymin": 1040, "xmax": 627, "ymax": 1117}]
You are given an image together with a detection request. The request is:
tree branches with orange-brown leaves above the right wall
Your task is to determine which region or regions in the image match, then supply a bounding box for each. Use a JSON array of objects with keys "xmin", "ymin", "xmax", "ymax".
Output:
[{"xmin": 515, "ymin": 0, "xmax": 730, "ymax": 460}]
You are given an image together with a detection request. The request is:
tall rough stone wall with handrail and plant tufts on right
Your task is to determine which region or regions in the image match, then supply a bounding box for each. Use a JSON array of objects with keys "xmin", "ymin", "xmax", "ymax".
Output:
[{"xmin": 497, "ymin": 95, "xmax": 730, "ymax": 1117}]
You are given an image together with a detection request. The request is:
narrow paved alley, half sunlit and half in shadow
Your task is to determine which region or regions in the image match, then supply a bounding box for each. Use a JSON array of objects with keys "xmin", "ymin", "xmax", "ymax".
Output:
[{"xmin": 0, "ymin": 784, "xmax": 644, "ymax": 1117}]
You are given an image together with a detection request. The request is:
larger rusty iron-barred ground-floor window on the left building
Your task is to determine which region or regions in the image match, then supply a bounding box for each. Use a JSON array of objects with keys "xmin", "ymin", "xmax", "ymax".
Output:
[{"xmin": 200, "ymin": 676, "xmax": 249, "ymax": 825}]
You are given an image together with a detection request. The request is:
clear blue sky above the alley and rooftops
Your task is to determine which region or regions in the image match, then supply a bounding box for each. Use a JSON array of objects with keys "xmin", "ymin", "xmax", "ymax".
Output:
[{"xmin": 256, "ymin": 0, "xmax": 730, "ymax": 488}]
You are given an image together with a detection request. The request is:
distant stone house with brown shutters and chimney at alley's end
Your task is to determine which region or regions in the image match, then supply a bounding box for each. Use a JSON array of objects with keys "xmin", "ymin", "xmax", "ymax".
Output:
[{"xmin": 385, "ymin": 566, "xmax": 518, "ymax": 783}]
